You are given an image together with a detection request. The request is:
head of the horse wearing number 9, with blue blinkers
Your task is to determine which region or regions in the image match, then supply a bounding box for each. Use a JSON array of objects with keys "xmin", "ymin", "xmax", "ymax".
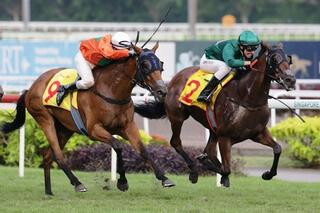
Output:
[{"xmin": 132, "ymin": 42, "xmax": 167, "ymax": 102}]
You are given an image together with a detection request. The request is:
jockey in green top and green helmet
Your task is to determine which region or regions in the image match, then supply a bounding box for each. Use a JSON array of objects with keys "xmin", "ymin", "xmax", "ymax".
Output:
[{"xmin": 197, "ymin": 30, "xmax": 261, "ymax": 103}]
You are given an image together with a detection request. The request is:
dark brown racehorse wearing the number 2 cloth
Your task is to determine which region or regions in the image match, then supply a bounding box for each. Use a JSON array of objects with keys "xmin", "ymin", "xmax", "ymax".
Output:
[{"xmin": 135, "ymin": 46, "xmax": 296, "ymax": 187}]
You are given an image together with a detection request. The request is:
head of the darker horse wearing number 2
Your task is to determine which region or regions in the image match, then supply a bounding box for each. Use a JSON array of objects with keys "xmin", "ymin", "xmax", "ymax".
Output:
[{"xmin": 267, "ymin": 44, "xmax": 296, "ymax": 90}]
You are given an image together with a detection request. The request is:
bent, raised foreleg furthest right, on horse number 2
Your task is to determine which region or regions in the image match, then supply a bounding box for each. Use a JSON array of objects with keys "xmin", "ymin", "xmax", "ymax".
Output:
[{"xmin": 253, "ymin": 128, "xmax": 281, "ymax": 180}]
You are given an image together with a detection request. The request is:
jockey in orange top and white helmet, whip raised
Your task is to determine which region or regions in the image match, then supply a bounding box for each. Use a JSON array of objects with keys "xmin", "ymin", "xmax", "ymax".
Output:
[{"xmin": 56, "ymin": 32, "xmax": 134, "ymax": 105}]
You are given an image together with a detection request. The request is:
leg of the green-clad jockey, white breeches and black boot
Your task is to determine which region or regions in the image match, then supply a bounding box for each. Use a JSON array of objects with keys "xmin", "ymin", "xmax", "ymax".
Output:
[{"xmin": 197, "ymin": 55, "xmax": 231, "ymax": 102}]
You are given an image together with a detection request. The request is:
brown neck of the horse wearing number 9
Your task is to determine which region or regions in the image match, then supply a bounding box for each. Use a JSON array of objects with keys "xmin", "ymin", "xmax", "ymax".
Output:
[{"xmin": 94, "ymin": 58, "xmax": 136, "ymax": 99}]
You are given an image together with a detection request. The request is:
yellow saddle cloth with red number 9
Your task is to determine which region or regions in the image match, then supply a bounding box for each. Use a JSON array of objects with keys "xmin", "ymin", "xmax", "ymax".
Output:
[{"xmin": 42, "ymin": 69, "xmax": 78, "ymax": 111}]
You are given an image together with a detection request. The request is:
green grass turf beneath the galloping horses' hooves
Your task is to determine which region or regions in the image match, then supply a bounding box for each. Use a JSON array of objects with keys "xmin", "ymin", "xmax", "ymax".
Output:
[{"xmin": 0, "ymin": 167, "xmax": 320, "ymax": 213}]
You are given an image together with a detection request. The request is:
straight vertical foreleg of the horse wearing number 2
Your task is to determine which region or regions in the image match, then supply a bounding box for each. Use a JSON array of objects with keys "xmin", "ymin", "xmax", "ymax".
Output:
[{"xmin": 218, "ymin": 137, "xmax": 231, "ymax": 187}]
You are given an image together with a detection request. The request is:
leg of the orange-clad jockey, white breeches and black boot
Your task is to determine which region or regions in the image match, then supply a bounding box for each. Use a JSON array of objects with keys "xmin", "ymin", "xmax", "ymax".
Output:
[{"xmin": 57, "ymin": 51, "xmax": 94, "ymax": 105}]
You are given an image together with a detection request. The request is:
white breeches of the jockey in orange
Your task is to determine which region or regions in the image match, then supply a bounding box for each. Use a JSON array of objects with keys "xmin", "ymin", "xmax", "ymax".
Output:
[{"xmin": 74, "ymin": 51, "xmax": 94, "ymax": 89}]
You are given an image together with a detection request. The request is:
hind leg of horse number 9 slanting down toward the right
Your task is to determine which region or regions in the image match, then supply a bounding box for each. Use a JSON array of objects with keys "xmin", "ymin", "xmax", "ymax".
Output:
[{"xmin": 31, "ymin": 110, "xmax": 87, "ymax": 192}]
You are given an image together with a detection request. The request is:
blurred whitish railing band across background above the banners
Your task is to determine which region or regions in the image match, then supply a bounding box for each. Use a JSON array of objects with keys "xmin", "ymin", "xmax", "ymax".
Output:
[{"xmin": 0, "ymin": 21, "xmax": 320, "ymax": 41}]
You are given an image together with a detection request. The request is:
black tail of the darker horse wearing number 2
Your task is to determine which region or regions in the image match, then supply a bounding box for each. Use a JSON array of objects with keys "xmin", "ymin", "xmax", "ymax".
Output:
[{"xmin": 134, "ymin": 101, "xmax": 167, "ymax": 119}]
